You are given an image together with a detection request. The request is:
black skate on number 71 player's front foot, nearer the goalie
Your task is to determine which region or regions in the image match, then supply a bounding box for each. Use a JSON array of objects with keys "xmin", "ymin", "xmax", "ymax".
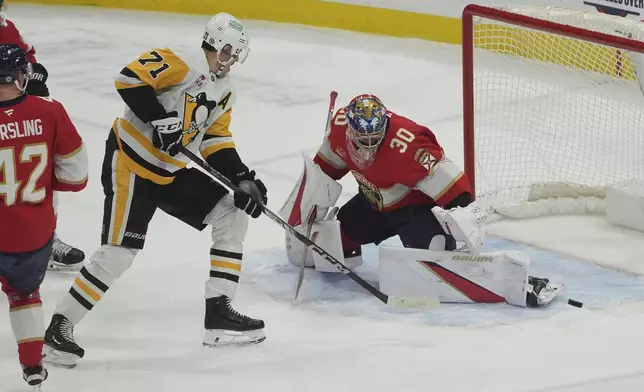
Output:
[{"xmin": 203, "ymin": 295, "xmax": 266, "ymax": 347}]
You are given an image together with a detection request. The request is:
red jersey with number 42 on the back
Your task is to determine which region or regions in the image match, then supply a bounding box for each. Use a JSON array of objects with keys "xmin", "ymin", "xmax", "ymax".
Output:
[{"xmin": 0, "ymin": 95, "xmax": 87, "ymax": 253}]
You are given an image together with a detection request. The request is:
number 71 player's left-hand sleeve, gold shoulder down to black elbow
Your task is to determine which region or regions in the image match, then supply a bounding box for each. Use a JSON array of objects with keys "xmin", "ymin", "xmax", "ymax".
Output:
[{"xmin": 114, "ymin": 48, "xmax": 190, "ymax": 122}]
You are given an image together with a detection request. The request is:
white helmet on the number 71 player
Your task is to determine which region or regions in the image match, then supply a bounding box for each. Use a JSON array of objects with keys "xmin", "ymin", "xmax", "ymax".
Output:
[{"xmin": 202, "ymin": 12, "xmax": 250, "ymax": 76}]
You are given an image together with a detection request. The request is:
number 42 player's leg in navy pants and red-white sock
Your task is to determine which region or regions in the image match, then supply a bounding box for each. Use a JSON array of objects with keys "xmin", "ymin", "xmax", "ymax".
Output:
[{"xmin": 0, "ymin": 237, "xmax": 53, "ymax": 367}]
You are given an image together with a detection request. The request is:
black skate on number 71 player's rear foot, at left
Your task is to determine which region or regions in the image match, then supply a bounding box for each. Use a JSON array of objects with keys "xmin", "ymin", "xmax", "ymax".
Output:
[{"xmin": 43, "ymin": 314, "xmax": 85, "ymax": 369}]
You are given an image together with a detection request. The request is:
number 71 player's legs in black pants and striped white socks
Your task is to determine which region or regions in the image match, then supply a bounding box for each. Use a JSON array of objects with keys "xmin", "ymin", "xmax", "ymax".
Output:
[{"xmin": 51, "ymin": 132, "xmax": 248, "ymax": 324}]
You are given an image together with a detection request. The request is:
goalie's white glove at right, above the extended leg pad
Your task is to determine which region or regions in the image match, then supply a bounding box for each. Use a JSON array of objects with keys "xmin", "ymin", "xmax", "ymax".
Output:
[{"xmin": 432, "ymin": 203, "xmax": 485, "ymax": 255}]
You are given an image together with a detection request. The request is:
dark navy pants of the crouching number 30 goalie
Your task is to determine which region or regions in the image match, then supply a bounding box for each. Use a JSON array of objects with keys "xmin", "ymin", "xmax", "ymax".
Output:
[{"xmin": 338, "ymin": 193, "xmax": 456, "ymax": 252}]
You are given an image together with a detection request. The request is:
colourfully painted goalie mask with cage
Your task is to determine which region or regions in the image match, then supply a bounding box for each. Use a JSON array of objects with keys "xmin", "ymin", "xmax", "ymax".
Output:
[{"xmin": 346, "ymin": 94, "xmax": 388, "ymax": 169}]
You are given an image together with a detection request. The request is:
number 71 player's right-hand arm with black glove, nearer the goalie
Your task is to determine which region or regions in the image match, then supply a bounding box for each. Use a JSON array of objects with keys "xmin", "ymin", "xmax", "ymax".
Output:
[{"xmin": 199, "ymin": 109, "xmax": 268, "ymax": 218}]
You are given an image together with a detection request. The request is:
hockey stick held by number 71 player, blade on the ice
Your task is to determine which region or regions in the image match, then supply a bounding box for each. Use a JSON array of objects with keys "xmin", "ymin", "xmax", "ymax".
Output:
[{"xmin": 179, "ymin": 150, "xmax": 440, "ymax": 308}]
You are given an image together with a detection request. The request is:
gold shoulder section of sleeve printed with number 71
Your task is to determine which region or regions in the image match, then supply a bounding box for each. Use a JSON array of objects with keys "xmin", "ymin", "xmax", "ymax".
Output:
[{"xmin": 115, "ymin": 48, "xmax": 190, "ymax": 91}]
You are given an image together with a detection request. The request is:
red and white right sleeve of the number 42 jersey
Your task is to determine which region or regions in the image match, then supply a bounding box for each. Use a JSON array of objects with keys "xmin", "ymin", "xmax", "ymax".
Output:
[{"xmin": 52, "ymin": 102, "xmax": 88, "ymax": 192}]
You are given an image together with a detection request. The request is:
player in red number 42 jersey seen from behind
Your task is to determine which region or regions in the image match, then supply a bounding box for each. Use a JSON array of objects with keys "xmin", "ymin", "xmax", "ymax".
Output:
[{"xmin": 0, "ymin": 44, "xmax": 87, "ymax": 386}]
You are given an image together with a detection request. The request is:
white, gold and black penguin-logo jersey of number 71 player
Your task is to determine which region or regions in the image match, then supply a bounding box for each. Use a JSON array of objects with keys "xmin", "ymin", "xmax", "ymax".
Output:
[{"xmin": 113, "ymin": 48, "xmax": 236, "ymax": 185}]
